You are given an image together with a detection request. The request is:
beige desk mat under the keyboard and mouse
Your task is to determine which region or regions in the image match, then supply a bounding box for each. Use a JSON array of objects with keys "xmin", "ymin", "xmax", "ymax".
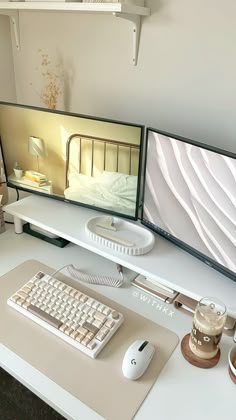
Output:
[{"xmin": 0, "ymin": 260, "xmax": 178, "ymax": 420}]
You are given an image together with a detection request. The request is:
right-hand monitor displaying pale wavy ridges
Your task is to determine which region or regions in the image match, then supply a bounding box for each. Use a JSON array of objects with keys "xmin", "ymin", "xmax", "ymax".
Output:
[{"xmin": 142, "ymin": 128, "xmax": 236, "ymax": 281}]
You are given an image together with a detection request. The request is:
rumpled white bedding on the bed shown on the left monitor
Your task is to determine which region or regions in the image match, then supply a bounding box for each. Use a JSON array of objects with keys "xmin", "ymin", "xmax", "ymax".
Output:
[{"xmin": 64, "ymin": 171, "xmax": 137, "ymax": 216}]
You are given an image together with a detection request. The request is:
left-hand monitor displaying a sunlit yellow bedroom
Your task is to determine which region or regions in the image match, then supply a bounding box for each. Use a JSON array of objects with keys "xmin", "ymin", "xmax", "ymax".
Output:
[{"xmin": 0, "ymin": 102, "xmax": 143, "ymax": 219}]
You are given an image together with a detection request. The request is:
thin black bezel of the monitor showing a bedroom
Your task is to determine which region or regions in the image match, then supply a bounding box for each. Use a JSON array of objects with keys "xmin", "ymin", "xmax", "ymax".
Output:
[{"xmin": 0, "ymin": 101, "xmax": 145, "ymax": 221}]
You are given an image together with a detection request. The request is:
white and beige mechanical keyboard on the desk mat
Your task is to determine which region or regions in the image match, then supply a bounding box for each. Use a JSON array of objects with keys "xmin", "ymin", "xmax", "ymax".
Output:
[{"xmin": 7, "ymin": 271, "xmax": 124, "ymax": 358}]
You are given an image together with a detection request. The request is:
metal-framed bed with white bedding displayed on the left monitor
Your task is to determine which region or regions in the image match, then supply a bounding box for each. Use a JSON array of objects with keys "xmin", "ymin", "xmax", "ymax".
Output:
[{"xmin": 64, "ymin": 134, "xmax": 139, "ymax": 216}]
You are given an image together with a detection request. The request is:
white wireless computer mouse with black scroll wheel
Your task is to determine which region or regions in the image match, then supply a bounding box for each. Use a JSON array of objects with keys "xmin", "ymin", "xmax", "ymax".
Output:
[{"xmin": 122, "ymin": 340, "xmax": 155, "ymax": 381}]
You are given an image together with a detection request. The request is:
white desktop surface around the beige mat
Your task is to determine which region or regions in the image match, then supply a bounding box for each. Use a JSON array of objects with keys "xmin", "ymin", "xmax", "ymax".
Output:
[{"xmin": 0, "ymin": 218, "xmax": 236, "ymax": 420}]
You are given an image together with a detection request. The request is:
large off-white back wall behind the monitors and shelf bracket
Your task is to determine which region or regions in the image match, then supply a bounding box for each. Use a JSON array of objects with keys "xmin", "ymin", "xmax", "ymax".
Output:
[{"xmin": 3, "ymin": 0, "xmax": 236, "ymax": 152}]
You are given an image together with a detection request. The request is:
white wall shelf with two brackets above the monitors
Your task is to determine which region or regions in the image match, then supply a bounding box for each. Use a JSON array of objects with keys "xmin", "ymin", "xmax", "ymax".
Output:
[{"xmin": 0, "ymin": 1, "xmax": 150, "ymax": 65}]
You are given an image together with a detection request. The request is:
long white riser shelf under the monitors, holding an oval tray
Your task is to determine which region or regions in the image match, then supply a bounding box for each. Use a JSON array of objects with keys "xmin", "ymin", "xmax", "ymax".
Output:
[{"xmin": 4, "ymin": 195, "xmax": 236, "ymax": 317}]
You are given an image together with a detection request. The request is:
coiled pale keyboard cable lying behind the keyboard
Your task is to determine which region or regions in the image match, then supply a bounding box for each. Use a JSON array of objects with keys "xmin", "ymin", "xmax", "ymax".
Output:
[{"xmin": 51, "ymin": 264, "xmax": 124, "ymax": 287}]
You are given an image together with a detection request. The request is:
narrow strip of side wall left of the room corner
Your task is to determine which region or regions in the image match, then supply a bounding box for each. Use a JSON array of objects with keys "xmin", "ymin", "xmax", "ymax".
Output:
[{"xmin": 0, "ymin": 15, "xmax": 16, "ymax": 101}]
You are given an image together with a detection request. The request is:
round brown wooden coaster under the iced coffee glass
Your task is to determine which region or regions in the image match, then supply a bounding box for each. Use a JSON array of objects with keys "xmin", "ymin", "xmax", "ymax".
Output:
[{"xmin": 181, "ymin": 334, "xmax": 220, "ymax": 369}]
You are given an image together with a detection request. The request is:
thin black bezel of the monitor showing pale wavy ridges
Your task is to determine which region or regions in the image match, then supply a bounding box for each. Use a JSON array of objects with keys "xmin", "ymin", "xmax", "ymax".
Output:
[{"xmin": 140, "ymin": 127, "xmax": 236, "ymax": 282}]
